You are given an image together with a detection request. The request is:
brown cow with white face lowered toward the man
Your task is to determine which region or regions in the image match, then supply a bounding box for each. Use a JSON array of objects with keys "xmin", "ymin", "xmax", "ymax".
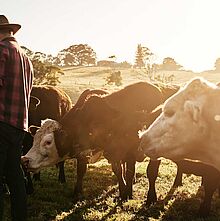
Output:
[{"xmin": 23, "ymin": 82, "xmax": 162, "ymax": 200}]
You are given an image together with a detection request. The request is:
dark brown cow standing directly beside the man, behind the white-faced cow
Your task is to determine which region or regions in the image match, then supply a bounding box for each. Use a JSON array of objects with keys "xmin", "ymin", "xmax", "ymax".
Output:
[{"xmin": 23, "ymin": 85, "xmax": 72, "ymax": 184}]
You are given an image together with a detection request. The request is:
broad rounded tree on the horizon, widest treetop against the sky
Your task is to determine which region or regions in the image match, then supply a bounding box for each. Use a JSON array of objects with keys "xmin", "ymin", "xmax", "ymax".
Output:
[{"xmin": 57, "ymin": 44, "xmax": 96, "ymax": 66}]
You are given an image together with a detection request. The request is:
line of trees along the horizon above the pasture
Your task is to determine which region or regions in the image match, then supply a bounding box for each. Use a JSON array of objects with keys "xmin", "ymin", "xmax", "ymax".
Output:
[{"xmin": 22, "ymin": 44, "xmax": 220, "ymax": 85}]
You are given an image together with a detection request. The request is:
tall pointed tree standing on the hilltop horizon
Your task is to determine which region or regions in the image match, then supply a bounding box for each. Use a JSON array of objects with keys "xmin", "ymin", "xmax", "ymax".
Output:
[{"xmin": 134, "ymin": 44, "xmax": 153, "ymax": 68}]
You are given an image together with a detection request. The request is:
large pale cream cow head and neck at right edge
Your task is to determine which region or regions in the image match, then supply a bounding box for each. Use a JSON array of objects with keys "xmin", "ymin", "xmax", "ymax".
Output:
[{"xmin": 139, "ymin": 78, "xmax": 220, "ymax": 170}]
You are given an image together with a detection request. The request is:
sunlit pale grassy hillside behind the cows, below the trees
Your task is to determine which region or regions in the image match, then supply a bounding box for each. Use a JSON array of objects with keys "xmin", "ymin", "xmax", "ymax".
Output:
[{"xmin": 59, "ymin": 67, "xmax": 220, "ymax": 102}]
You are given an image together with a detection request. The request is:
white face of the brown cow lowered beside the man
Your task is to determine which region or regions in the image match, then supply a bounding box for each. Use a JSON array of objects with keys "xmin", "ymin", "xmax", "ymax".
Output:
[{"xmin": 22, "ymin": 119, "xmax": 62, "ymax": 172}]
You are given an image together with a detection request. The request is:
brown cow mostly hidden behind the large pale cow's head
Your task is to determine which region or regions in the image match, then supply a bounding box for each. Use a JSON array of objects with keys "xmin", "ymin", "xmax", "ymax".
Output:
[{"xmin": 140, "ymin": 81, "xmax": 220, "ymax": 217}]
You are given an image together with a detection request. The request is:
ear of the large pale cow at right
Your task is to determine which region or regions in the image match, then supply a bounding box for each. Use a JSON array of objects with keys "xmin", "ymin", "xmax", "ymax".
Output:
[{"xmin": 184, "ymin": 101, "xmax": 202, "ymax": 122}]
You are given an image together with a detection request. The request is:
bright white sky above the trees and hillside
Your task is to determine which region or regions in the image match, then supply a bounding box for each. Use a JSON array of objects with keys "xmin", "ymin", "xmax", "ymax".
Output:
[{"xmin": 0, "ymin": 0, "xmax": 220, "ymax": 72}]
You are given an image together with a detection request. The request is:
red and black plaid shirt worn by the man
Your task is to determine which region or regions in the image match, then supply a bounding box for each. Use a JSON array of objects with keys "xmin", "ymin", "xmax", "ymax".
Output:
[{"xmin": 0, "ymin": 37, "xmax": 33, "ymax": 130}]
